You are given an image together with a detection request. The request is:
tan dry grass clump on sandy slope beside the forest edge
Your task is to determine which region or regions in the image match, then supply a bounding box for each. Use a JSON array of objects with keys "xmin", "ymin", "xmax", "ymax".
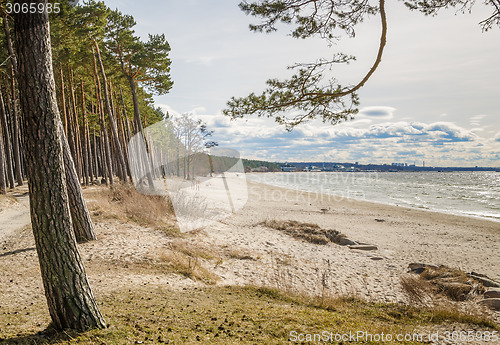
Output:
[{"xmin": 84, "ymin": 185, "xmax": 179, "ymax": 235}]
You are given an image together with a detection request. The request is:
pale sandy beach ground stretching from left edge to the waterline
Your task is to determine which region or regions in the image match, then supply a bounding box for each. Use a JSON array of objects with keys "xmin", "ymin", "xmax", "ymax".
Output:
[{"xmin": 0, "ymin": 182, "xmax": 500, "ymax": 344}]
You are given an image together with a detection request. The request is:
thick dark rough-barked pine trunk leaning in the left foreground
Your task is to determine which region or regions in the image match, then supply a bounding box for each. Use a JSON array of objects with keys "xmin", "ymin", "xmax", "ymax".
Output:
[{"xmin": 14, "ymin": 0, "xmax": 105, "ymax": 330}]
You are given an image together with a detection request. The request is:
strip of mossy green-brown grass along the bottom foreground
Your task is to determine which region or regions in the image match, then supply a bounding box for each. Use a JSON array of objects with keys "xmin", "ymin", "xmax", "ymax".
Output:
[{"xmin": 0, "ymin": 287, "xmax": 499, "ymax": 345}]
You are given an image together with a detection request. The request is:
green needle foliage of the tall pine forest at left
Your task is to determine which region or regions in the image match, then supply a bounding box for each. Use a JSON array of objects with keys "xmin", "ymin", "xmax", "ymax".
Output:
[{"xmin": 44, "ymin": 0, "xmax": 173, "ymax": 132}]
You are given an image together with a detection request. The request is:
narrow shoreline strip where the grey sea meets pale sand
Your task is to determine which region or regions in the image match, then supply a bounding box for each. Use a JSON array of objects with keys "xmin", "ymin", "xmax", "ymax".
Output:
[{"xmin": 245, "ymin": 171, "xmax": 500, "ymax": 226}]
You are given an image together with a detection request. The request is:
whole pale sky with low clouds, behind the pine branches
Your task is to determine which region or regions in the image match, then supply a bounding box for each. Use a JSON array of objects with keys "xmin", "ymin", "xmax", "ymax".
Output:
[{"xmin": 101, "ymin": 0, "xmax": 500, "ymax": 167}]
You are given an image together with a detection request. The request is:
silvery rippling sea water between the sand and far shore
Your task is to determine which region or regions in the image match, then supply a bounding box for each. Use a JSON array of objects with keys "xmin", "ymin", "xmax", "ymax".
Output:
[{"xmin": 247, "ymin": 171, "xmax": 500, "ymax": 222}]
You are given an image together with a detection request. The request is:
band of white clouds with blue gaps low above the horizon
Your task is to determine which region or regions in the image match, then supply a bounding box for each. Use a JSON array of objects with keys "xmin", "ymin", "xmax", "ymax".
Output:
[{"xmin": 157, "ymin": 103, "xmax": 500, "ymax": 166}]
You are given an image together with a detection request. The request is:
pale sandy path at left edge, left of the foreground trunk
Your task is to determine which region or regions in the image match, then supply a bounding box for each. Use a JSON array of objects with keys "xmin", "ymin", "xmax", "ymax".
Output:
[{"xmin": 0, "ymin": 187, "xmax": 31, "ymax": 243}]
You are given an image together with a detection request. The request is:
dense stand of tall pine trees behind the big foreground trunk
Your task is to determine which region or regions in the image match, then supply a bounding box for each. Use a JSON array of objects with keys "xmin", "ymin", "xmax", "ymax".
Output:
[{"xmin": 0, "ymin": 0, "xmax": 173, "ymax": 193}]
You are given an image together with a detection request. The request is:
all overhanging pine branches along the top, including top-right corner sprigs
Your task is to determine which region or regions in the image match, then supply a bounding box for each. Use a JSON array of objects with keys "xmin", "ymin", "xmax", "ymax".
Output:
[{"xmin": 223, "ymin": 0, "xmax": 500, "ymax": 130}]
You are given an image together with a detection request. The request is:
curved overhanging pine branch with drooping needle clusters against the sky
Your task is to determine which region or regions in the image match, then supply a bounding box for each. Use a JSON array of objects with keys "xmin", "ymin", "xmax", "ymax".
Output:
[{"xmin": 224, "ymin": 0, "xmax": 387, "ymax": 130}]
